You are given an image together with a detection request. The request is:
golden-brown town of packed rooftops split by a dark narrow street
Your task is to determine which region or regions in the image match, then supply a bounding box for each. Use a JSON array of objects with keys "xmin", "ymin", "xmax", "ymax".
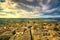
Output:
[{"xmin": 0, "ymin": 21, "xmax": 60, "ymax": 40}]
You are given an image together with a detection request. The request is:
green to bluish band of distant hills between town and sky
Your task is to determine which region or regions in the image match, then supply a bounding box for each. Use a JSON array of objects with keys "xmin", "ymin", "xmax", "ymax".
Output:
[{"xmin": 0, "ymin": 18, "xmax": 60, "ymax": 23}]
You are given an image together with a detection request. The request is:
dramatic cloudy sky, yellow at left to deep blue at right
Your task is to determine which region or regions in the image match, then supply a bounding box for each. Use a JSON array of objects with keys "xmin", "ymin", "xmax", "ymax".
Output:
[{"xmin": 0, "ymin": 0, "xmax": 60, "ymax": 18}]
